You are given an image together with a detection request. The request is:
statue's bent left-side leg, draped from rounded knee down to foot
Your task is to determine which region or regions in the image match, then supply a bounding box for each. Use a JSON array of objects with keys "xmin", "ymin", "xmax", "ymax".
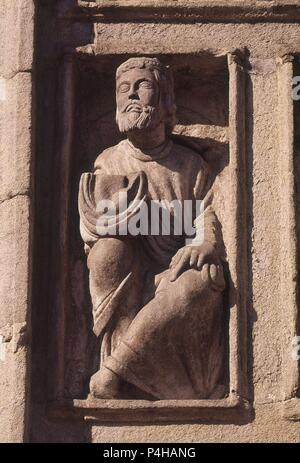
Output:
[{"xmin": 88, "ymin": 238, "xmax": 142, "ymax": 397}]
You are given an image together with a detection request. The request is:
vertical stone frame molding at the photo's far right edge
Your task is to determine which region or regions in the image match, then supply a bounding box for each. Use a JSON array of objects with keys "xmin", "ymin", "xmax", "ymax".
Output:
[{"xmin": 277, "ymin": 54, "xmax": 300, "ymax": 421}]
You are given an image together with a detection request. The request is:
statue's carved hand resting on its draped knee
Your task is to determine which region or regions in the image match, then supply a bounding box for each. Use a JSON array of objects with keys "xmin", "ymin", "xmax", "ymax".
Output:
[{"xmin": 170, "ymin": 242, "xmax": 220, "ymax": 281}]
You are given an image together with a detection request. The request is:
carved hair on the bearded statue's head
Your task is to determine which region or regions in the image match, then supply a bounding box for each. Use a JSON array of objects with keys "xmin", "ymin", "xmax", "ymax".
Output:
[{"xmin": 116, "ymin": 57, "xmax": 176, "ymax": 134}]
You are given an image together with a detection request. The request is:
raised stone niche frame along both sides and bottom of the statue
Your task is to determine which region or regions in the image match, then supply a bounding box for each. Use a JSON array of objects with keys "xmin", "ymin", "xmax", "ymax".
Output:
[{"xmin": 47, "ymin": 48, "xmax": 250, "ymax": 423}]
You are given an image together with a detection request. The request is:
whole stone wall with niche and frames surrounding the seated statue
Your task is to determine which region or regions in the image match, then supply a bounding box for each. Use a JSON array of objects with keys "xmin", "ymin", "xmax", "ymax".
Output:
[{"xmin": 0, "ymin": 0, "xmax": 300, "ymax": 442}]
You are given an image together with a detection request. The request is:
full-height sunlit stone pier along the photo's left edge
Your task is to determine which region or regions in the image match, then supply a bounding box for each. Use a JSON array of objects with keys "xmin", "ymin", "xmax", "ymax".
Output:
[{"xmin": 0, "ymin": 0, "xmax": 34, "ymax": 442}]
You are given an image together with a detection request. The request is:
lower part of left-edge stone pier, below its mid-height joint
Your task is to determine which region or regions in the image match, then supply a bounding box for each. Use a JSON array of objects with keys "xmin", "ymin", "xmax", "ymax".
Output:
[{"xmin": 0, "ymin": 196, "xmax": 31, "ymax": 442}]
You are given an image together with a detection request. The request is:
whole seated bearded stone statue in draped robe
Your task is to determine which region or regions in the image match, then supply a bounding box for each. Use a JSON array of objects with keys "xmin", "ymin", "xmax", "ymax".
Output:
[{"xmin": 79, "ymin": 57, "xmax": 225, "ymax": 400}]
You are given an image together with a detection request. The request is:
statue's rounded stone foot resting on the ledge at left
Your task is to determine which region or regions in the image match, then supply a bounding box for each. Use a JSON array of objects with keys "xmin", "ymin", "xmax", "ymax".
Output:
[{"xmin": 90, "ymin": 367, "xmax": 119, "ymax": 399}]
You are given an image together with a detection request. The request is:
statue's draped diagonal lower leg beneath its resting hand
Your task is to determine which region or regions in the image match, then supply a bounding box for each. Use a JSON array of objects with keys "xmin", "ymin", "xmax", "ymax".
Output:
[{"xmin": 104, "ymin": 266, "xmax": 224, "ymax": 399}]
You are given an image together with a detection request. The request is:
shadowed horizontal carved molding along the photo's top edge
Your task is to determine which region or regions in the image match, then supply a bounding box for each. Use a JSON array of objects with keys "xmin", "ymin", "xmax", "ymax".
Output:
[{"xmin": 66, "ymin": 0, "xmax": 300, "ymax": 23}]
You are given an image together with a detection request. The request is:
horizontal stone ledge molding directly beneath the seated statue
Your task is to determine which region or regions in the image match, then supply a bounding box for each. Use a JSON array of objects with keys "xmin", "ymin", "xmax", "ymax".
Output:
[{"xmin": 48, "ymin": 397, "xmax": 252, "ymax": 424}]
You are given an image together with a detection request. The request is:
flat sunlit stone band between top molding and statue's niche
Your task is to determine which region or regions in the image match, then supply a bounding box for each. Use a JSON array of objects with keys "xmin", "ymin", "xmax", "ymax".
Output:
[{"xmin": 93, "ymin": 22, "xmax": 300, "ymax": 59}]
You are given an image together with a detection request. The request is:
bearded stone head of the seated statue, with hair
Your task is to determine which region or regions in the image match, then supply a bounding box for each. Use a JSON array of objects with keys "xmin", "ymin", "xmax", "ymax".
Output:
[{"xmin": 116, "ymin": 57, "xmax": 176, "ymax": 133}]
